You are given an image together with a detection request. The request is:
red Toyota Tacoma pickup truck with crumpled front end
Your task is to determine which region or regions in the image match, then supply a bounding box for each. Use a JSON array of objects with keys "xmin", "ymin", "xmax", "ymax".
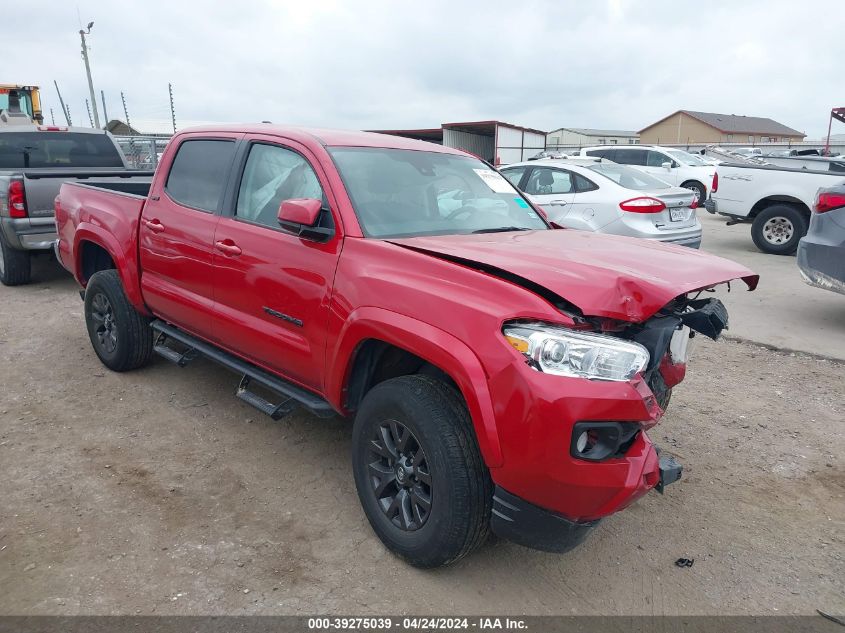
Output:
[{"xmin": 56, "ymin": 125, "xmax": 757, "ymax": 567}]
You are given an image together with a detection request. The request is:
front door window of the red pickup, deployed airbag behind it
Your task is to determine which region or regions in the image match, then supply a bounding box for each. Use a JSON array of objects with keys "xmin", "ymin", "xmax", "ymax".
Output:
[{"xmin": 235, "ymin": 144, "xmax": 323, "ymax": 229}]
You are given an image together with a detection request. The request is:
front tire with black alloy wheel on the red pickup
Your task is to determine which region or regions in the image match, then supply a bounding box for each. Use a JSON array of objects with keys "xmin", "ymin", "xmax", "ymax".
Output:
[{"xmin": 352, "ymin": 374, "xmax": 493, "ymax": 568}]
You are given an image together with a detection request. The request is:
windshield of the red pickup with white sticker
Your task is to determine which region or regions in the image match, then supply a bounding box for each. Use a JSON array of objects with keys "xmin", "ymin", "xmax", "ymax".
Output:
[{"xmin": 330, "ymin": 147, "xmax": 549, "ymax": 238}]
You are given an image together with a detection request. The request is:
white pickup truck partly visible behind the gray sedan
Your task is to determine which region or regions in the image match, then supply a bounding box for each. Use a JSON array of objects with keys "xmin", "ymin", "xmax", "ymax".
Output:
[{"xmin": 704, "ymin": 163, "xmax": 845, "ymax": 255}]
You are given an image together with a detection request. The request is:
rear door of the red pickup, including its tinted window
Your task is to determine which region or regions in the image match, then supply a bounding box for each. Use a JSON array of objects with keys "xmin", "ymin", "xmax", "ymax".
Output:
[{"xmin": 138, "ymin": 133, "xmax": 237, "ymax": 339}]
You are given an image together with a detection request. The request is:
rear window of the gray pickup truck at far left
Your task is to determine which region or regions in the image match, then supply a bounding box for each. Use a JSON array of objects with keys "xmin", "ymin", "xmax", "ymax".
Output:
[{"xmin": 0, "ymin": 132, "xmax": 123, "ymax": 169}]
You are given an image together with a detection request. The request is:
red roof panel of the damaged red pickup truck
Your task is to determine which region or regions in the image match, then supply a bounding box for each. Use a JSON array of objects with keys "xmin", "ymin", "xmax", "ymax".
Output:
[{"xmin": 179, "ymin": 123, "xmax": 467, "ymax": 156}]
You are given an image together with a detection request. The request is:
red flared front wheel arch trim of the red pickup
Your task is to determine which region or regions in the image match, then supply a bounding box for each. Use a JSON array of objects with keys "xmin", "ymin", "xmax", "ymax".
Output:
[{"xmin": 326, "ymin": 306, "xmax": 503, "ymax": 468}]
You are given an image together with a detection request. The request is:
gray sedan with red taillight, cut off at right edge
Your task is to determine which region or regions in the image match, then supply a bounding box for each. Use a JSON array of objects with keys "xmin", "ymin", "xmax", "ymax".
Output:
[{"xmin": 798, "ymin": 185, "xmax": 845, "ymax": 294}]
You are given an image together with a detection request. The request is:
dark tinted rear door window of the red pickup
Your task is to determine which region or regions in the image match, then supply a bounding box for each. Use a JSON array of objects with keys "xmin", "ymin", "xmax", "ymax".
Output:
[{"xmin": 164, "ymin": 140, "xmax": 235, "ymax": 213}]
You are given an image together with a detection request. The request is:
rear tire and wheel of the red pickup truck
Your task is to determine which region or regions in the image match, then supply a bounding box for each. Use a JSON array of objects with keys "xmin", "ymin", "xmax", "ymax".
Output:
[{"xmin": 85, "ymin": 270, "xmax": 153, "ymax": 371}]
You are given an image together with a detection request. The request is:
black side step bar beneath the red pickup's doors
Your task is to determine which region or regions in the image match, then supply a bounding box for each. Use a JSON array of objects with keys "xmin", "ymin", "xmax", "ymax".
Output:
[{"xmin": 150, "ymin": 319, "xmax": 335, "ymax": 420}]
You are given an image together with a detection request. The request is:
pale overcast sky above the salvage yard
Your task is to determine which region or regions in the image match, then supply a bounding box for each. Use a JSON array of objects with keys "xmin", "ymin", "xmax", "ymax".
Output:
[{"xmin": 0, "ymin": 0, "xmax": 845, "ymax": 139}]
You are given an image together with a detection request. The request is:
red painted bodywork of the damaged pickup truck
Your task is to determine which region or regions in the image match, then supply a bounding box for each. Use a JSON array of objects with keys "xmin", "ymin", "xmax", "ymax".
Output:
[{"xmin": 57, "ymin": 125, "xmax": 757, "ymax": 519}]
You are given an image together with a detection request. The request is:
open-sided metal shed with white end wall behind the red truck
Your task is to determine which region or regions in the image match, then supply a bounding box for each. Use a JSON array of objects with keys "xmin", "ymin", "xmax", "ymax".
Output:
[{"xmin": 368, "ymin": 121, "xmax": 546, "ymax": 165}]
